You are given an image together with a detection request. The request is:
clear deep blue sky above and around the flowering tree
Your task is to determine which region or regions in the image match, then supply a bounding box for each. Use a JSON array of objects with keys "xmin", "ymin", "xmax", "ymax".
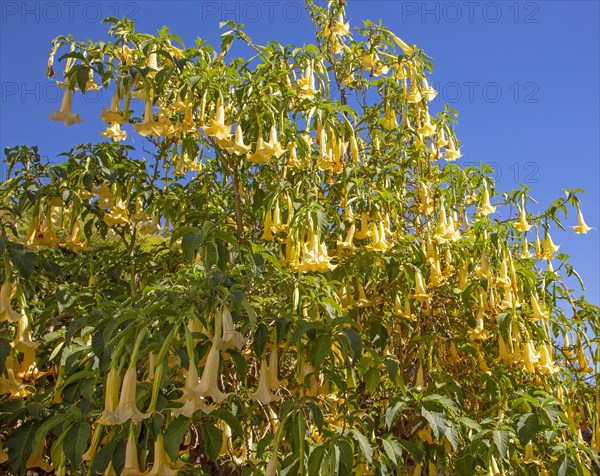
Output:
[{"xmin": 0, "ymin": 0, "xmax": 600, "ymax": 304}]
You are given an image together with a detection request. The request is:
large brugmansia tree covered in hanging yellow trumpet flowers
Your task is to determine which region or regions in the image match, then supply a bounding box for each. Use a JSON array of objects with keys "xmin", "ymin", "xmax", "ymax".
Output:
[{"xmin": 0, "ymin": 0, "xmax": 600, "ymax": 475}]
